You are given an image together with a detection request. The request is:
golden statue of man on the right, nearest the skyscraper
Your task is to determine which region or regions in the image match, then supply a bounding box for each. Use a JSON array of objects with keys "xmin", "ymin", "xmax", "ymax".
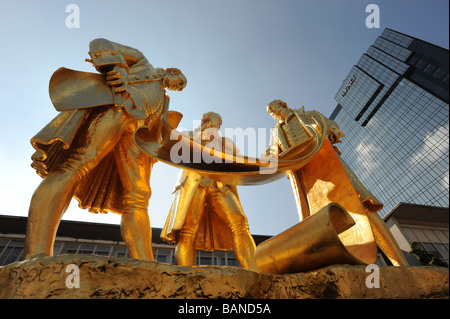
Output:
[{"xmin": 266, "ymin": 100, "xmax": 408, "ymax": 266}]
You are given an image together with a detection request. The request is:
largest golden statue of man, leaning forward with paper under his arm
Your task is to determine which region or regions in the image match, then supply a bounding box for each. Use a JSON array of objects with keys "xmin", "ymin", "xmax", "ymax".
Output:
[{"xmin": 25, "ymin": 39, "xmax": 187, "ymax": 260}]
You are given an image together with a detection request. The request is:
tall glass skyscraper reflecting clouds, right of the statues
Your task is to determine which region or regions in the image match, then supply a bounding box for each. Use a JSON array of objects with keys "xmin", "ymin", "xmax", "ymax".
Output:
[{"xmin": 330, "ymin": 29, "xmax": 449, "ymax": 216}]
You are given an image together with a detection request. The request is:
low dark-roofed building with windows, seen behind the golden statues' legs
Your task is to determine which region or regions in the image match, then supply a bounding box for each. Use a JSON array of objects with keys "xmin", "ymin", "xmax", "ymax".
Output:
[{"xmin": 0, "ymin": 215, "xmax": 270, "ymax": 267}]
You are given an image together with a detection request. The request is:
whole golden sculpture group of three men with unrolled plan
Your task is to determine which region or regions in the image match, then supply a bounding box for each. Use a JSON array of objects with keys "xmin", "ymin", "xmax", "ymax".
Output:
[{"xmin": 25, "ymin": 39, "xmax": 407, "ymax": 273}]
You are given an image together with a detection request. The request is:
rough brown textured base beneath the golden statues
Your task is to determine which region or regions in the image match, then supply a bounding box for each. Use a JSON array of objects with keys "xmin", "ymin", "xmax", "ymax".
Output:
[{"xmin": 0, "ymin": 255, "xmax": 449, "ymax": 299}]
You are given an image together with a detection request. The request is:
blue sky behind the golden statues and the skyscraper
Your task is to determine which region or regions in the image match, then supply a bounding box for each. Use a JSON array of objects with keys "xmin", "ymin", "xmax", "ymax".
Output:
[{"xmin": 0, "ymin": 0, "xmax": 449, "ymax": 235}]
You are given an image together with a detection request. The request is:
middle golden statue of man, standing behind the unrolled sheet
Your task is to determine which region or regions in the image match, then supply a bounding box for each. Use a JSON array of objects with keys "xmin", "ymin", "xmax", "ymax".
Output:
[{"xmin": 161, "ymin": 112, "xmax": 258, "ymax": 271}]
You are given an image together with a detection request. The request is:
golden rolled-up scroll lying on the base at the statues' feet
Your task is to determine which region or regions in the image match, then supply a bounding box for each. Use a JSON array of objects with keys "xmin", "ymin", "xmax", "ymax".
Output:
[{"xmin": 255, "ymin": 203, "xmax": 365, "ymax": 274}]
